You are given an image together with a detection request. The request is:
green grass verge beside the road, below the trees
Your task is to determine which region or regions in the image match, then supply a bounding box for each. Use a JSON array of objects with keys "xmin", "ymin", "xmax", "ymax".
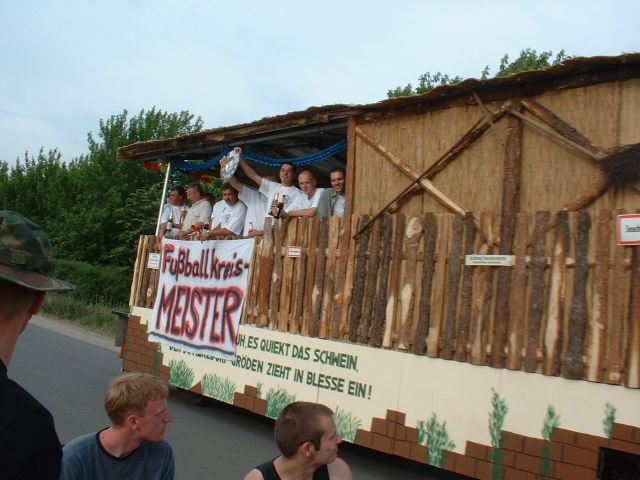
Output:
[{"xmin": 42, "ymin": 292, "xmax": 129, "ymax": 335}]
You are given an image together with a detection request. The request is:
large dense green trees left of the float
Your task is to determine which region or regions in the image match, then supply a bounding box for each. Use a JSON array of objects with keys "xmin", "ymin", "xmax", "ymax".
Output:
[{"xmin": 0, "ymin": 107, "xmax": 202, "ymax": 266}]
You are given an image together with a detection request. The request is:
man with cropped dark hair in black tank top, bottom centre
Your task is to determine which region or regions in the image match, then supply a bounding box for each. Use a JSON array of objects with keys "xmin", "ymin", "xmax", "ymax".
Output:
[{"xmin": 244, "ymin": 402, "xmax": 353, "ymax": 480}]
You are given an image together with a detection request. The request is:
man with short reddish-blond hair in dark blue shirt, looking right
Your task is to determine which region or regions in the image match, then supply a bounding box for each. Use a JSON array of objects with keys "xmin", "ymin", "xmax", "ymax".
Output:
[{"xmin": 60, "ymin": 374, "xmax": 174, "ymax": 480}]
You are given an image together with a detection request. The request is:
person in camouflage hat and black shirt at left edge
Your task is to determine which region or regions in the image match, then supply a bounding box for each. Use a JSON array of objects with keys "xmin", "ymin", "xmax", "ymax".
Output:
[{"xmin": 0, "ymin": 210, "xmax": 74, "ymax": 479}]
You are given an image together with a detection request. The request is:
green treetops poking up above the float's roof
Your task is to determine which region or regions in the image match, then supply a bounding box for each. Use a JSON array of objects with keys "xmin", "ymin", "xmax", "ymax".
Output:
[{"xmin": 387, "ymin": 48, "xmax": 571, "ymax": 98}]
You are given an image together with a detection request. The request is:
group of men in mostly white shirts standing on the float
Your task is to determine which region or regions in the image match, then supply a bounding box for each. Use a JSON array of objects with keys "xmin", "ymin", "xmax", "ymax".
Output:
[{"xmin": 160, "ymin": 158, "xmax": 345, "ymax": 240}]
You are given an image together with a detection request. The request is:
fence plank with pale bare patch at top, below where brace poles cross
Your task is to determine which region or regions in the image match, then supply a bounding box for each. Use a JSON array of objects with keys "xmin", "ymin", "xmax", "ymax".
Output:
[{"xmin": 398, "ymin": 217, "xmax": 423, "ymax": 350}]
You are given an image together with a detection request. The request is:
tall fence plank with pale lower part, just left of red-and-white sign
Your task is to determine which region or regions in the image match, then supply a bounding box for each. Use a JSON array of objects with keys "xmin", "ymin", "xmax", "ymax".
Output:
[{"xmin": 586, "ymin": 210, "xmax": 612, "ymax": 382}]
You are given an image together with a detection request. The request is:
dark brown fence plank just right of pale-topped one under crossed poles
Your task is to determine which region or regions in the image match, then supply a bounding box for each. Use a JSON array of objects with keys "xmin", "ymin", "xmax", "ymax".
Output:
[{"xmin": 413, "ymin": 213, "xmax": 438, "ymax": 355}]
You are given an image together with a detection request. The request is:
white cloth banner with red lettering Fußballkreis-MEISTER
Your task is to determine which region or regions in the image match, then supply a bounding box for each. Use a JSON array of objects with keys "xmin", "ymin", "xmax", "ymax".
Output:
[{"xmin": 149, "ymin": 238, "xmax": 255, "ymax": 360}]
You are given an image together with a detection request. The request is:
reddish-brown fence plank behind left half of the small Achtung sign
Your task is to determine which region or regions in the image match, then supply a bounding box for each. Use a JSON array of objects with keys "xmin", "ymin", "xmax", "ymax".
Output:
[{"xmin": 469, "ymin": 213, "xmax": 496, "ymax": 365}]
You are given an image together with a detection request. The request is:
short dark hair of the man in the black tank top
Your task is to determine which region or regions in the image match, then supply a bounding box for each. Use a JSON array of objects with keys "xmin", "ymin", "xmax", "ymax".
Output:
[{"xmin": 274, "ymin": 402, "xmax": 333, "ymax": 458}]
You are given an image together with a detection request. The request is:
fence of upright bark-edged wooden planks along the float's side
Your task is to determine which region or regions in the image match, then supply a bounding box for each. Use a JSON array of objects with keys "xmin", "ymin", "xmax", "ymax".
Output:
[{"xmin": 131, "ymin": 210, "xmax": 640, "ymax": 388}]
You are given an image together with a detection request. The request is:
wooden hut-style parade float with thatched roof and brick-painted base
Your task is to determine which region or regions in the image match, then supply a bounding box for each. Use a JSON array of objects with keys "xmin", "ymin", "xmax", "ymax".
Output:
[{"xmin": 118, "ymin": 54, "xmax": 640, "ymax": 479}]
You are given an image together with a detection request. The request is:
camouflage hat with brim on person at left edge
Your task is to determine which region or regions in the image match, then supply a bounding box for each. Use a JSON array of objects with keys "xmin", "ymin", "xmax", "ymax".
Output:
[{"xmin": 0, "ymin": 210, "xmax": 76, "ymax": 291}]
